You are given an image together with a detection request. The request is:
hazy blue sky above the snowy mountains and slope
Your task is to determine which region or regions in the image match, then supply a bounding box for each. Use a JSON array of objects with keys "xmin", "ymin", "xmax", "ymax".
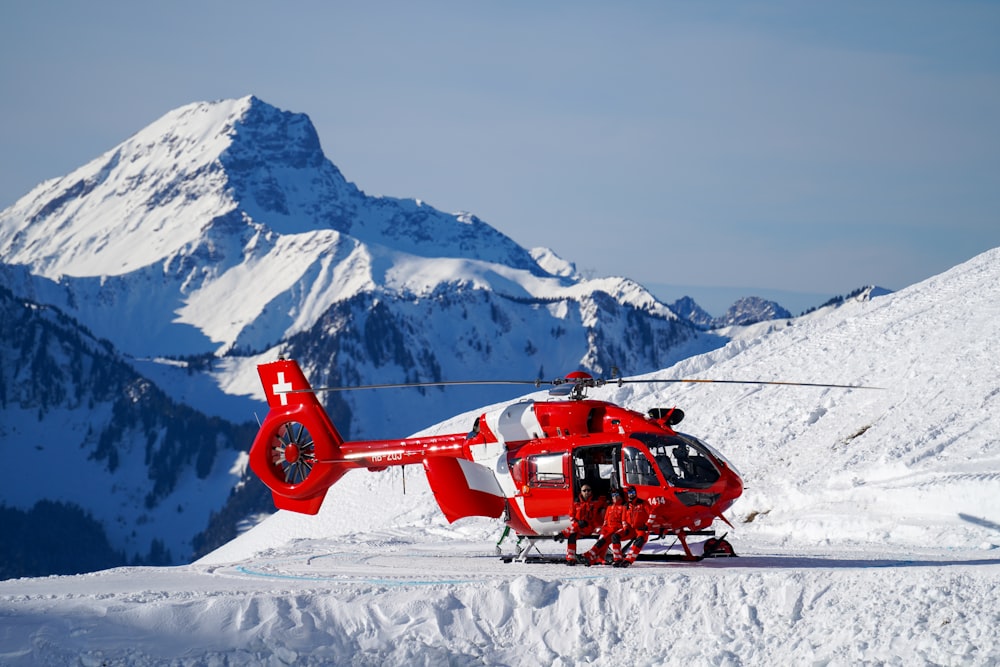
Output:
[{"xmin": 0, "ymin": 0, "xmax": 1000, "ymax": 314}]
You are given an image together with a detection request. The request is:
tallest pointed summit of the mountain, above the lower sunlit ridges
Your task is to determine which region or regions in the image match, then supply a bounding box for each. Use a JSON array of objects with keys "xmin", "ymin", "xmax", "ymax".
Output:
[{"xmin": 0, "ymin": 96, "xmax": 543, "ymax": 278}]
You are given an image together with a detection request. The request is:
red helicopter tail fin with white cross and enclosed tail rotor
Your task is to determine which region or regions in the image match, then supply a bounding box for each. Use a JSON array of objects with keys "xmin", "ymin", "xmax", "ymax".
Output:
[{"xmin": 250, "ymin": 359, "xmax": 354, "ymax": 514}]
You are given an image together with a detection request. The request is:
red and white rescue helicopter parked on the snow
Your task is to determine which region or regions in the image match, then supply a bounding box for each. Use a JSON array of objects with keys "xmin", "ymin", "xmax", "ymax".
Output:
[{"xmin": 250, "ymin": 359, "xmax": 868, "ymax": 560}]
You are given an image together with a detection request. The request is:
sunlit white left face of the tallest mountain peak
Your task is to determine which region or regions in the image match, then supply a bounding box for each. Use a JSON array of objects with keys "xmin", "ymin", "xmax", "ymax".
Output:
[{"xmin": 0, "ymin": 98, "xmax": 258, "ymax": 278}]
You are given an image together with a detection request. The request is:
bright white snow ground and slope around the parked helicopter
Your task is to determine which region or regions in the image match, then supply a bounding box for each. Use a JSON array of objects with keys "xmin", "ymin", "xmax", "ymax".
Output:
[{"xmin": 0, "ymin": 250, "xmax": 1000, "ymax": 665}]
